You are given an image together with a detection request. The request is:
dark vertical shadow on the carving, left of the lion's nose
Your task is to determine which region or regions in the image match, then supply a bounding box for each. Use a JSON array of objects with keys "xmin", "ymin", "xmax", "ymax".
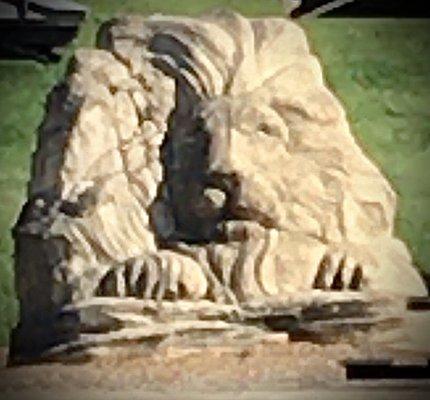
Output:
[{"xmin": 150, "ymin": 34, "xmax": 232, "ymax": 247}]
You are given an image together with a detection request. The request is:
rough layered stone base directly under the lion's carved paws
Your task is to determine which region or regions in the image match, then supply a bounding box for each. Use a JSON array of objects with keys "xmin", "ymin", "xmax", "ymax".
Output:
[{"xmin": 33, "ymin": 292, "xmax": 430, "ymax": 362}]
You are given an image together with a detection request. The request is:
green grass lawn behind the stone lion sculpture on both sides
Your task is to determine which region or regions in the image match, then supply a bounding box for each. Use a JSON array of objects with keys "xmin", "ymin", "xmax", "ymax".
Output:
[{"xmin": 0, "ymin": 0, "xmax": 430, "ymax": 345}]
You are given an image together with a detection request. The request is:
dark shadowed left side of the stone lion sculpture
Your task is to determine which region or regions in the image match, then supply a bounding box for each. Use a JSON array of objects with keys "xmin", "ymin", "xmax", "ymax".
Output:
[{"xmin": 10, "ymin": 84, "xmax": 81, "ymax": 359}]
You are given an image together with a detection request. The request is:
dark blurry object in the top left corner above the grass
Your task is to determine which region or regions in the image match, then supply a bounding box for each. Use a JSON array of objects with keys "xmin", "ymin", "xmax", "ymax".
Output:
[{"xmin": 0, "ymin": 0, "xmax": 88, "ymax": 61}]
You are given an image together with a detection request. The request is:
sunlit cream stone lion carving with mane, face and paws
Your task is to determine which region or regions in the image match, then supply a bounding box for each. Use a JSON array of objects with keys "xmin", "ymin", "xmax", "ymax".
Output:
[{"xmin": 29, "ymin": 13, "xmax": 426, "ymax": 301}]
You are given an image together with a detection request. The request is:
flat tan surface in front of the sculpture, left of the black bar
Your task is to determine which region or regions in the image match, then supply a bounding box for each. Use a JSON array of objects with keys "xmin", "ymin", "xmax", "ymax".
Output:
[{"xmin": 0, "ymin": 342, "xmax": 356, "ymax": 393}]
